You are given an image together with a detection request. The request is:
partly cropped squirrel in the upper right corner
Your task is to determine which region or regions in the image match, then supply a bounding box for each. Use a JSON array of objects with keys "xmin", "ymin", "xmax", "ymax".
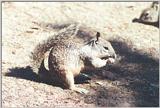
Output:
[{"xmin": 133, "ymin": 1, "xmax": 160, "ymax": 26}]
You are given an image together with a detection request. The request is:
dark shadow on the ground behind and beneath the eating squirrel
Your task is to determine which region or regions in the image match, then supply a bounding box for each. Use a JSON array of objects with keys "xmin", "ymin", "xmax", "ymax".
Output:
[{"xmin": 4, "ymin": 62, "xmax": 90, "ymax": 88}]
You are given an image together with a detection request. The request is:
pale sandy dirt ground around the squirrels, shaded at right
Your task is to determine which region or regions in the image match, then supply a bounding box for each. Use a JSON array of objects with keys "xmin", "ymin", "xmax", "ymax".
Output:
[{"xmin": 2, "ymin": 2, "xmax": 159, "ymax": 107}]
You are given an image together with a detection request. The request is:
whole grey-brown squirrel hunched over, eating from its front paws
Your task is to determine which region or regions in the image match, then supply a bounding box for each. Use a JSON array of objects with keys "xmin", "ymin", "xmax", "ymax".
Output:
[{"xmin": 32, "ymin": 24, "xmax": 116, "ymax": 92}]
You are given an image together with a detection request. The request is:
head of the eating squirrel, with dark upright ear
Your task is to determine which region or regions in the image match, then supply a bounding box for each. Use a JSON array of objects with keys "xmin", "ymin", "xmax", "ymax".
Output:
[{"xmin": 83, "ymin": 32, "xmax": 116, "ymax": 59}]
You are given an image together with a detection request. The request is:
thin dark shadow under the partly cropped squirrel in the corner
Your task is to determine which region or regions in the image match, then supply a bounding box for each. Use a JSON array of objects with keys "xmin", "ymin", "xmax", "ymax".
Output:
[{"xmin": 132, "ymin": 18, "xmax": 159, "ymax": 28}]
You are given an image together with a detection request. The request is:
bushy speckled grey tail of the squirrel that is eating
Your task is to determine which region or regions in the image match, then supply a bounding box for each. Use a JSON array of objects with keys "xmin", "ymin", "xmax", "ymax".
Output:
[{"xmin": 30, "ymin": 23, "xmax": 79, "ymax": 73}]
